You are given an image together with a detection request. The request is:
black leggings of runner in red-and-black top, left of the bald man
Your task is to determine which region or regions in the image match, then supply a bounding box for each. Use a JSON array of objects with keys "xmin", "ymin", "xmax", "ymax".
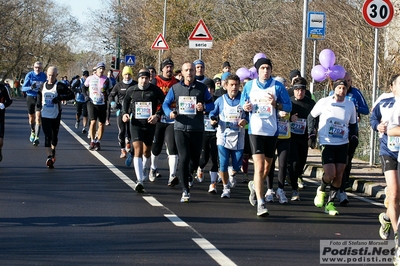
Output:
[{"xmin": 151, "ymin": 122, "xmax": 178, "ymax": 156}]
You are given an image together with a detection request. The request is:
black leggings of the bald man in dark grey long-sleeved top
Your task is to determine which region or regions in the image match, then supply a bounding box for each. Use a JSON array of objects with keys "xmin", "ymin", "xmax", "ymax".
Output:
[{"xmin": 174, "ymin": 130, "xmax": 203, "ymax": 192}]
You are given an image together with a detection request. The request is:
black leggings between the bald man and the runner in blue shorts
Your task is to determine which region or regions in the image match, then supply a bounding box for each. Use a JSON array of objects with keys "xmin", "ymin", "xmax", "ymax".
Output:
[{"xmin": 199, "ymin": 131, "xmax": 218, "ymax": 172}]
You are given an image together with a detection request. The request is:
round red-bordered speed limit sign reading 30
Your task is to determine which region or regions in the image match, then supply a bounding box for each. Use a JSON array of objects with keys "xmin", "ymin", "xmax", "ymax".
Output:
[{"xmin": 363, "ymin": 0, "xmax": 394, "ymax": 28}]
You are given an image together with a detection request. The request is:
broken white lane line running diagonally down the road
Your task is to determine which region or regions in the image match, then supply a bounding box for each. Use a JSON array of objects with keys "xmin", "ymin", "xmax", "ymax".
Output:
[{"xmin": 61, "ymin": 121, "xmax": 236, "ymax": 266}]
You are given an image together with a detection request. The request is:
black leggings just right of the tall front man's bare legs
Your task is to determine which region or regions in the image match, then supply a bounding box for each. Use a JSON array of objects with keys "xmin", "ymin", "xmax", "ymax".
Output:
[{"xmin": 267, "ymin": 139, "xmax": 290, "ymax": 189}]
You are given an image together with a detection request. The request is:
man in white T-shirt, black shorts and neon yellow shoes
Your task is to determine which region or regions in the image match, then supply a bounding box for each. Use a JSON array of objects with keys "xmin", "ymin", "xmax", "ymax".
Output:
[{"xmin": 308, "ymin": 79, "xmax": 358, "ymax": 215}]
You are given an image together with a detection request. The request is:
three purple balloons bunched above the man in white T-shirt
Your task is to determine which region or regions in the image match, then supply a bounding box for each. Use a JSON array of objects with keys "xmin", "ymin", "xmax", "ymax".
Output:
[{"xmin": 311, "ymin": 49, "xmax": 346, "ymax": 82}]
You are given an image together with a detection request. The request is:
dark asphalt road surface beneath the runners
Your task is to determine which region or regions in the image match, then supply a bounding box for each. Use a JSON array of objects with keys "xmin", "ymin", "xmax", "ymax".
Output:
[{"xmin": 0, "ymin": 99, "xmax": 393, "ymax": 266}]
